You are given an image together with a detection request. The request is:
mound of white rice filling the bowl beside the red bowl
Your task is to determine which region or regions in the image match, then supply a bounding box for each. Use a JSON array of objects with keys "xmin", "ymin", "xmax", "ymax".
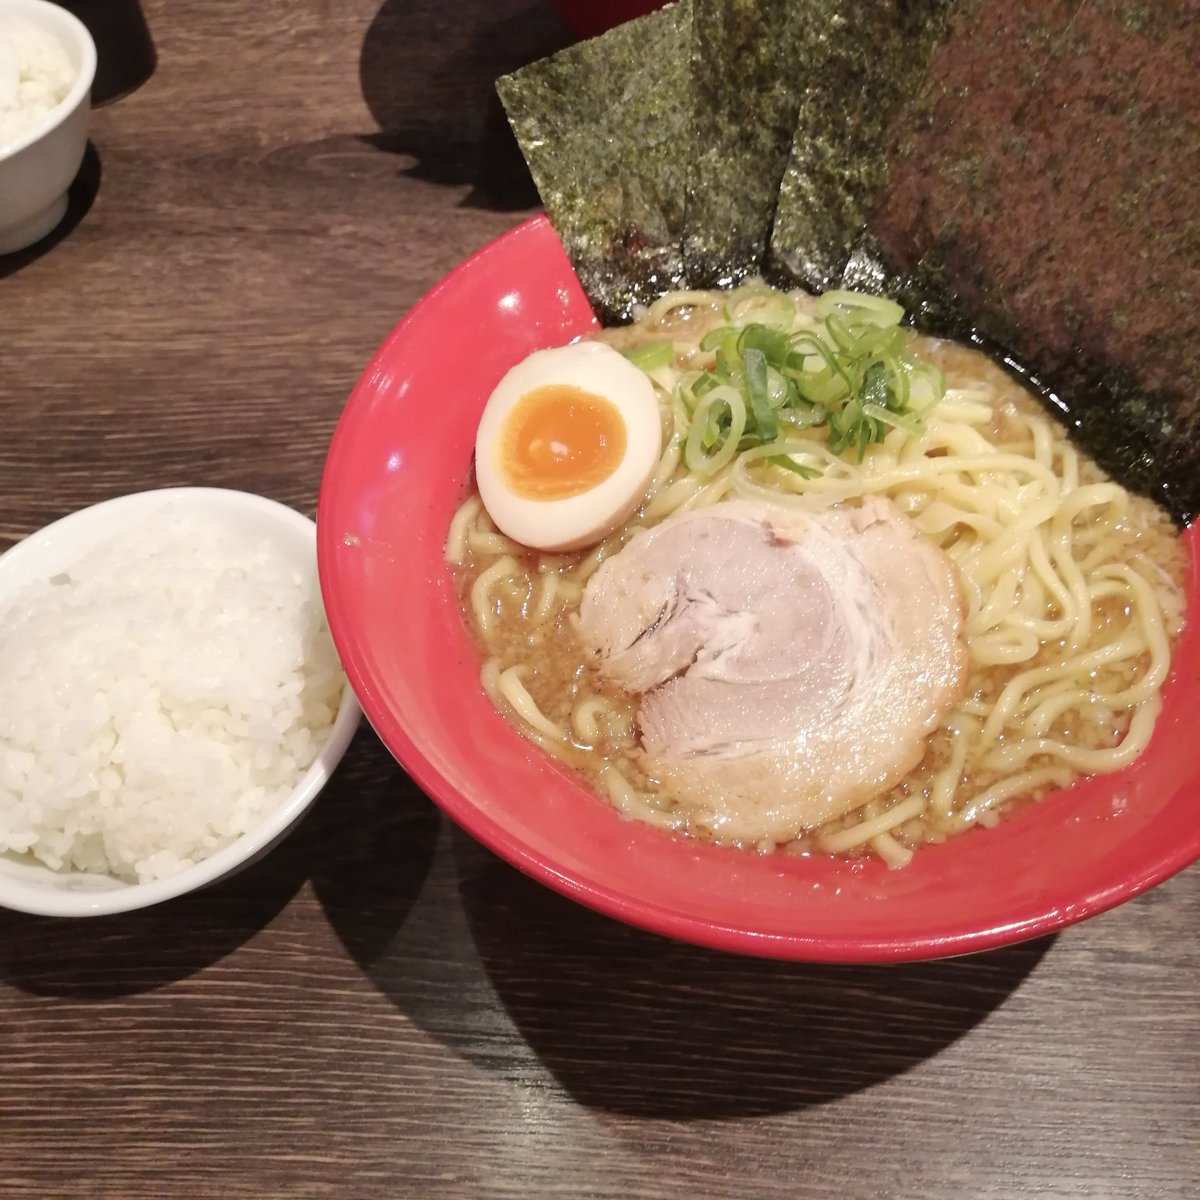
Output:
[{"xmin": 0, "ymin": 510, "xmax": 344, "ymax": 881}]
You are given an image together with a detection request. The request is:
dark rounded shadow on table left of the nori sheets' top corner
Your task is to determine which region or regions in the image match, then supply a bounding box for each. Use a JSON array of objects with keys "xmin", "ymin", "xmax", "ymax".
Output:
[{"xmin": 359, "ymin": 0, "xmax": 571, "ymax": 211}]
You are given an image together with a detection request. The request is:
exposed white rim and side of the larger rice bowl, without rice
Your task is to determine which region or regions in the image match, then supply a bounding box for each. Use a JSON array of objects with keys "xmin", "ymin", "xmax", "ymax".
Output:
[{"xmin": 0, "ymin": 487, "xmax": 361, "ymax": 917}]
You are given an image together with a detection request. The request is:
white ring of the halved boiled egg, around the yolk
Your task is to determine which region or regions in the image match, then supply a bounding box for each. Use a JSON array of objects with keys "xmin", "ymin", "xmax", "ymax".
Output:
[{"xmin": 475, "ymin": 342, "xmax": 662, "ymax": 552}]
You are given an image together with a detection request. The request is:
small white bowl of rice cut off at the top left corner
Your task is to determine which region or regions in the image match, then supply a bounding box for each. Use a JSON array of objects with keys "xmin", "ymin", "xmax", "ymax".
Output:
[{"xmin": 0, "ymin": 0, "xmax": 96, "ymax": 254}]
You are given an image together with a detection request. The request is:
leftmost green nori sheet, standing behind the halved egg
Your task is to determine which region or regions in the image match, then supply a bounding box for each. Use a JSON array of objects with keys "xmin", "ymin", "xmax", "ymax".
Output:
[{"xmin": 497, "ymin": 0, "xmax": 692, "ymax": 323}]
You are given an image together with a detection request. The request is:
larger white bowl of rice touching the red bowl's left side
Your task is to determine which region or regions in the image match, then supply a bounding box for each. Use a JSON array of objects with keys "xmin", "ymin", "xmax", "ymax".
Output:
[{"xmin": 0, "ymin": 487, "xmax": 359, "ymax": 917}]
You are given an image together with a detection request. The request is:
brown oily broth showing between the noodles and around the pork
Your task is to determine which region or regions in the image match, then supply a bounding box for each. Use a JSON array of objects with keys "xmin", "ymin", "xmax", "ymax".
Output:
[{"xmin": 456, "ymin": 296, "xmax": 1184, "ymax": 854}]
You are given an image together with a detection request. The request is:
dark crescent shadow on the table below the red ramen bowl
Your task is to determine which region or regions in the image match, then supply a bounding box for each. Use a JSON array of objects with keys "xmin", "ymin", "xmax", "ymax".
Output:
[{"xmin": 455, "ymin": 836, "xmax": 1052, "ymax": 1120}]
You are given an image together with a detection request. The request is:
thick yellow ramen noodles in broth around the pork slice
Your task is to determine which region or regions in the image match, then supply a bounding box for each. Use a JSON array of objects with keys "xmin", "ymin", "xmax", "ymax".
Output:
[{"xmin": 446, "ymin": 293, "xmax": 1182, "ymax": 866}]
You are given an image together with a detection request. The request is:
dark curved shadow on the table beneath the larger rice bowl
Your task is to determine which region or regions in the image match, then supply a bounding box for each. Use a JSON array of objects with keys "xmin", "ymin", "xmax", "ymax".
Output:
[{"xmin": 0, "ymin": 728, "xmax": 436, "ymax": 1000}]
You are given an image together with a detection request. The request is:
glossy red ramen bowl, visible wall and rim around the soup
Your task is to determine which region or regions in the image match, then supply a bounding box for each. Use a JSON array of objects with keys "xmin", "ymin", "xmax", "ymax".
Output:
[{"xmin": 317, "ymin": 218, "xmax": 1200, "ymax": 962}]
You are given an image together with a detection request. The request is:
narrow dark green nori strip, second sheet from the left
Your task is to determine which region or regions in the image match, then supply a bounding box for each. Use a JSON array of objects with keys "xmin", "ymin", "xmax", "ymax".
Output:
[{"xmin": 683, "ymin": 0, "xmax": 824, "ymax": 288}]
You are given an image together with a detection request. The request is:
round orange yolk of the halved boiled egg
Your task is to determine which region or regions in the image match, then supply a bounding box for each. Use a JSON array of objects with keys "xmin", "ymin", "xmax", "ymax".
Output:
[{"xmin": 499, "ymin": 384, "xmax": 625, "ymax": 500}]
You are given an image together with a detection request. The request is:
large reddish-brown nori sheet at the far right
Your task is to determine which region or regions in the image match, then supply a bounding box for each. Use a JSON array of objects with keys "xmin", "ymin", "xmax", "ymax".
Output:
[{"xmin": 870, "ymin": 0, "xmax": 1200, "ymax": 522}]
